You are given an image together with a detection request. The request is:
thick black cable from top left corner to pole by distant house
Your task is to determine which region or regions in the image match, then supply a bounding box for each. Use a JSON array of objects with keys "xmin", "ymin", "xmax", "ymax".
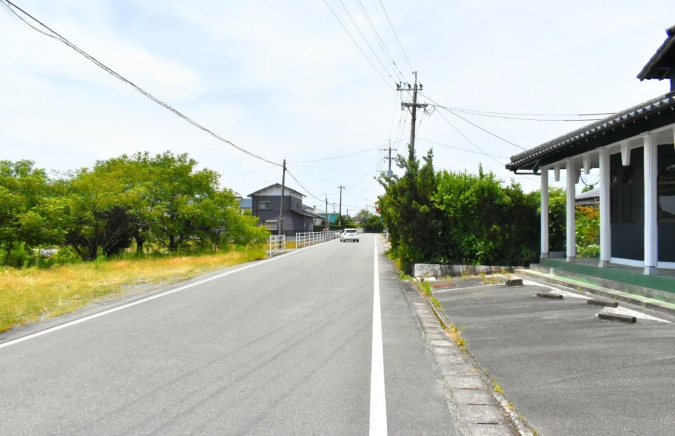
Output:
[{"xmin": 0, "ymin": 0, "xmax": 281, "ymax": 166}]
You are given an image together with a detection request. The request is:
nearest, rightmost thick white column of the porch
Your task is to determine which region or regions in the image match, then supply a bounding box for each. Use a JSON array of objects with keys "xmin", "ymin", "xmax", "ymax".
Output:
[{"xmin": 642, "ymin": 135, "xmax": 659, "ymax": 275}]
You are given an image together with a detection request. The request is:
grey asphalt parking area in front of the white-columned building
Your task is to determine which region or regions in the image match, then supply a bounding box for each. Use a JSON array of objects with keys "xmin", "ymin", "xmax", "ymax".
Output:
[{"xmin": 434, "ymin": 278, "xmax": 675, "ymax": 436}]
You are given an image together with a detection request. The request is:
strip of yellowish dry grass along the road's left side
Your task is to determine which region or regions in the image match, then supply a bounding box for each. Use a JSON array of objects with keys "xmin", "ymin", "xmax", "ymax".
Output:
[{"xmin": 0, "ymin": 247, "xmax": 266, "ymax": 332}]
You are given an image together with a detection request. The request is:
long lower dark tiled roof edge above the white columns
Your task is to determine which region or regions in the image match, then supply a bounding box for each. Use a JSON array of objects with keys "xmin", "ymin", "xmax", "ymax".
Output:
[{"xmin": 506, "ymin": 92, "xmax": 675, "ymax": 172}]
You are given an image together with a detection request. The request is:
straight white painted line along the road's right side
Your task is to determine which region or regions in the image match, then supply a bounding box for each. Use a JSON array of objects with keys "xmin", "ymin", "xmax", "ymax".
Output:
[{"xmin": 370, "ymin": 237, "xmax": 387, "ymax": 436}]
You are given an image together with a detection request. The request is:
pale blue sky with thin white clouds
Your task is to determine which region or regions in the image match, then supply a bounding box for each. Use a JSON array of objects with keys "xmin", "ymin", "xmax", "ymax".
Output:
[{"xmin": 0, "ymin": 0, "xmax": 675, "ymax": 214}]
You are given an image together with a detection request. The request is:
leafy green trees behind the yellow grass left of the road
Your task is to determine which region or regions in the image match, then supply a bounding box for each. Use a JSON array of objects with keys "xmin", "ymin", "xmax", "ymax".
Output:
[{"xmin": 0, "ymin": 152, "xmax": 268, "ymax": 267}]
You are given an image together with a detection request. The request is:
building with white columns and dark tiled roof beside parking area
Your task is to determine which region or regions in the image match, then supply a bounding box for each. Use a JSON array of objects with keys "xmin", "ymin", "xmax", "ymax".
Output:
[{"xmin": 506, "ymin": 26, "xmax": 675, "ymax": 275}]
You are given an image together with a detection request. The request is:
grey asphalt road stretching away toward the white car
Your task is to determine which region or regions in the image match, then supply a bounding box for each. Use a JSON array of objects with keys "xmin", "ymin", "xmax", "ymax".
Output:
[{"xmin": 0, "ymin": 235, "xmax": 457, "ymax": 436}]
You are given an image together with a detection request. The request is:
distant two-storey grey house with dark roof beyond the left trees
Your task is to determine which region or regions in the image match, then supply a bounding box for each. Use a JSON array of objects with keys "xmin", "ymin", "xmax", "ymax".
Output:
[{"xmin": 248, "ymin": 183, "xmax": 317, "ymax": 236}]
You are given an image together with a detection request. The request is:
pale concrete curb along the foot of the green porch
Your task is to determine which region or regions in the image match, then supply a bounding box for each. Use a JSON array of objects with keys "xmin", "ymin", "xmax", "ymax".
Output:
[{"xmin": 516, "ymin": 269, "xmax": 675, "ymax": 315}]
